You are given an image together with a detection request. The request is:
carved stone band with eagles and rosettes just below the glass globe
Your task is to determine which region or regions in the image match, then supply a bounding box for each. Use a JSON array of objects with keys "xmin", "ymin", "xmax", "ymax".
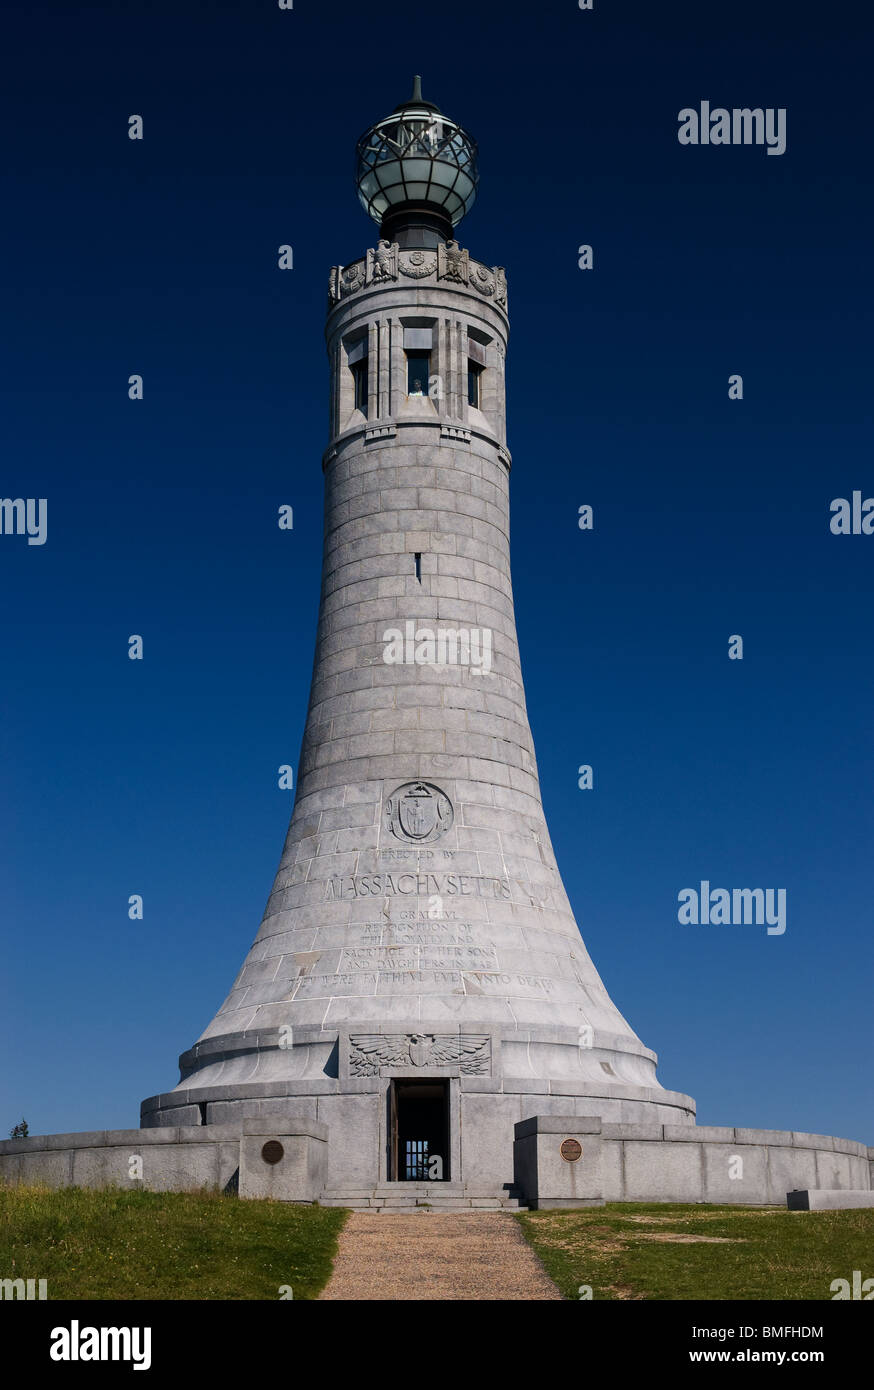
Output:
[{"xmin": 328, "ymin": 240, "xmax": 507, "ymax": 313}]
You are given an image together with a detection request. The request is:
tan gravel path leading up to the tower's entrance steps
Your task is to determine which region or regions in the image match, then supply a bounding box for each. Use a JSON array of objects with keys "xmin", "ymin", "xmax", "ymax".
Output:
[{"xmin": 321, "ymin": 1212, "xmax": 561, "ymax": 1301}]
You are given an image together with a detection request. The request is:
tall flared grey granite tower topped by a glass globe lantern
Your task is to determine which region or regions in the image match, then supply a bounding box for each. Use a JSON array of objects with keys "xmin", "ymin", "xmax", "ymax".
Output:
[{"xmin": 143, "ymin": 79, "xmax": 695, "ymax": 1190}]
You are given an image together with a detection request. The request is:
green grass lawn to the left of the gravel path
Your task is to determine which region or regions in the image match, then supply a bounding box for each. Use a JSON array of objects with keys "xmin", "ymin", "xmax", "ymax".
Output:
[{"xmin": 0, "ymin": 1187, "xmax": 347, "ymax": 1300}]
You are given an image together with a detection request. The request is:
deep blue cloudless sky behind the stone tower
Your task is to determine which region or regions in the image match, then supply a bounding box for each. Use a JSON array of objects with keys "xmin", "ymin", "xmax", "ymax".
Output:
[{"xmin": 0, "ymin": 0, "xmax": 874, "ymax": 1143}]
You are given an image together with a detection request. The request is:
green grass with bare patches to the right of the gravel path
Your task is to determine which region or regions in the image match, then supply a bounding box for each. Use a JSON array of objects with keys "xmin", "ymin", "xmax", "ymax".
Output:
[{"xmin": 517, "ymin": 1202, "xmax": 874, "ymax": 1300}]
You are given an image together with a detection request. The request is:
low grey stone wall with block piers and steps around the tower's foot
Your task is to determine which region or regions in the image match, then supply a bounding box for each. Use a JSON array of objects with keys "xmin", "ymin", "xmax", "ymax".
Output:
[{"xmin": 0, "ymin": 1113, "xmax": 874, "ymax": 1209}]
